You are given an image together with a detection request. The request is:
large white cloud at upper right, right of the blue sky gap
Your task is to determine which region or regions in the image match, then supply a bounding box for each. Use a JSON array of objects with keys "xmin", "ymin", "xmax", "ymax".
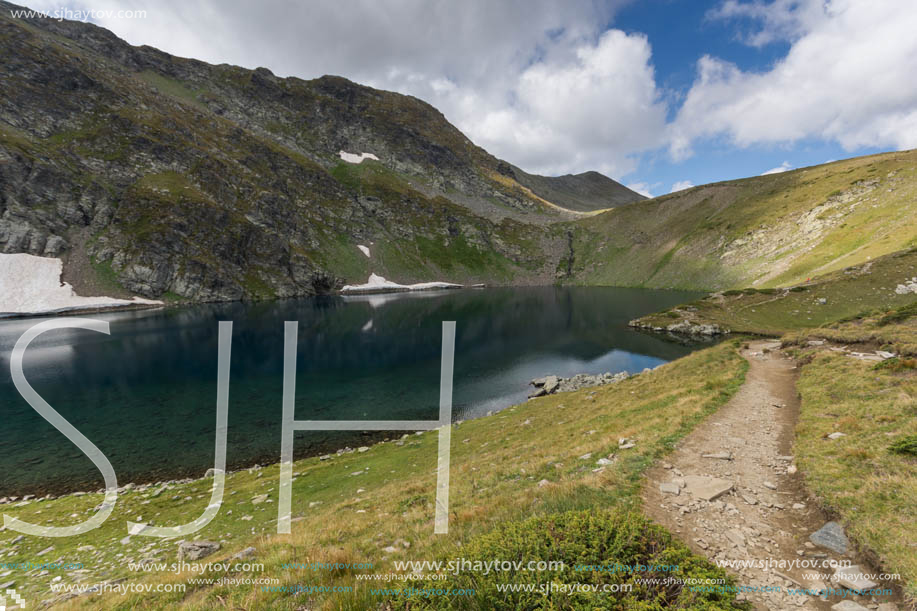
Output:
[{"xmin": 670, "ymin": 0, "xmax": 917, "ymax": 159}]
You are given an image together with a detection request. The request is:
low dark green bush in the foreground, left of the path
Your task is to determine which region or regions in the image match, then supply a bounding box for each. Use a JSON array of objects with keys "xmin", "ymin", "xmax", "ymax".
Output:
[{"xmin": 389, "ymin": 510, "xmax": 750, "ymax": 611}]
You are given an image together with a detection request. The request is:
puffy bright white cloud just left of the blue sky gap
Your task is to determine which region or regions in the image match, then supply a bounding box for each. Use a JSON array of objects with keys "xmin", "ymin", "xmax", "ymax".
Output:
[{"xmin": 466, "ymin": 30, "xmax": 666, "ymax": 177}]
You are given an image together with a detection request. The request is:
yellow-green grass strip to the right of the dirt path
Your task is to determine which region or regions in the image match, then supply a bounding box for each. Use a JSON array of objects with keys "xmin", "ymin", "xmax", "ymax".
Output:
[{"xmin": 784, "ymin": 318, "xmax": 917, "ymax": 601}]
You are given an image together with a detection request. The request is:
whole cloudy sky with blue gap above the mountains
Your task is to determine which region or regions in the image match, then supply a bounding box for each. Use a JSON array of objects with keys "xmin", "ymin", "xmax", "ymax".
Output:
[{"xmin": 17, "ymin": 0, "xmax": 917, "ymax": 196}]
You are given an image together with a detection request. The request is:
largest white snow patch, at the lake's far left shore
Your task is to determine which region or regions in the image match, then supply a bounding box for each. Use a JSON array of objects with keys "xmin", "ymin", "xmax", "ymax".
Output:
[{"xmin": 0, "ymin": 254, "xmax": 162, "ymax": 314}]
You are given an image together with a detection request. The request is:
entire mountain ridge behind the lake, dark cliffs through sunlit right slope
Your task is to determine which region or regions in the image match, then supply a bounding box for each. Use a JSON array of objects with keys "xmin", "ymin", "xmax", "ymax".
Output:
[{"xmin": 0, "ymin": 2, "xmax": 917, "ymax": 301}]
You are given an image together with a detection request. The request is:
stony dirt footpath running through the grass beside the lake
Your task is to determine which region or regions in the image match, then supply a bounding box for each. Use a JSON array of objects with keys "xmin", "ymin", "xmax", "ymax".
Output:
[{"xmin": 643, "ymin": 341, "xmax": 898, "ymax": 611}]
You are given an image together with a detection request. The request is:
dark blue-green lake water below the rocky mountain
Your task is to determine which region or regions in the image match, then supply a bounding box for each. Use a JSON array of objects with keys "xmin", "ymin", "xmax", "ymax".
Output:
[{"xmin": 0, "ymin": 287, "xmax": 697, "ymax": 496}]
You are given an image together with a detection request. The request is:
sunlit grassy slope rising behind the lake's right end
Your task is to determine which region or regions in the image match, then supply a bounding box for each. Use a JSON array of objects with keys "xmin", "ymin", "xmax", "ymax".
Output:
[{"xmin": 567, "ymin": 151, "xmax": 917, "ymax": 290}]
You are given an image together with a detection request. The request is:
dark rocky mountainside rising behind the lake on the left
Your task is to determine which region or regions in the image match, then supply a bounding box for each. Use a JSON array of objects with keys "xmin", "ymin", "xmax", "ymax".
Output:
[{"xmin": 0, "ymin": 2, "xmax": 640, "ymax": 301}]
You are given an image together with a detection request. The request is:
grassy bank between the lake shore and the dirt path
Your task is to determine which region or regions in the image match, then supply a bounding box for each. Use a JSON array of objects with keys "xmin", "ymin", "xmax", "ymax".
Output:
[{"xmin": 0, "ymin": 342, "xmax": 747, "ymax": 610}]
